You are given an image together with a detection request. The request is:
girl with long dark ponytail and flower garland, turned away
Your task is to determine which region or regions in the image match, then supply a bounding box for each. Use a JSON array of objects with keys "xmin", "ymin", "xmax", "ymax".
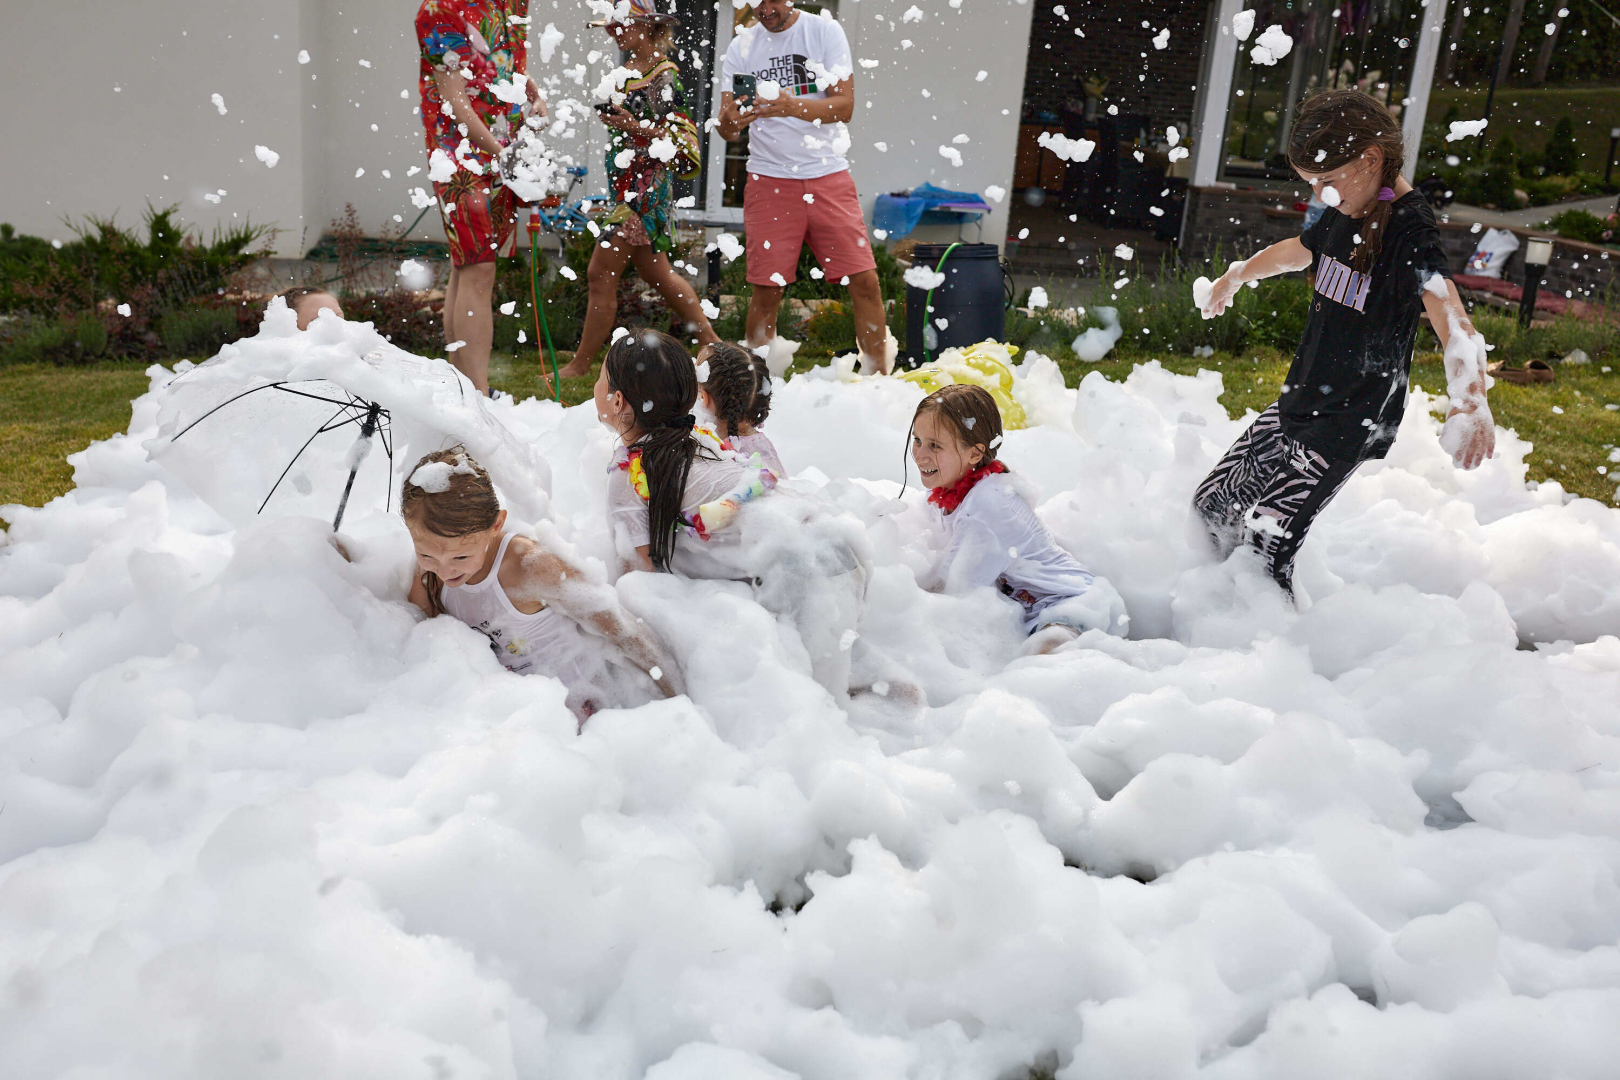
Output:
[{"xmin": 596, "ymin": 330, "xmax": 868, "ymax": 699}]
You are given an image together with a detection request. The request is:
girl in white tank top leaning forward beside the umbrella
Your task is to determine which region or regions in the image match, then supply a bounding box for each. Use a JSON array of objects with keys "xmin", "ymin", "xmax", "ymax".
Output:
[{"xmin": 400, "ymin": 447, "xmax": 680, "ymax": 725}]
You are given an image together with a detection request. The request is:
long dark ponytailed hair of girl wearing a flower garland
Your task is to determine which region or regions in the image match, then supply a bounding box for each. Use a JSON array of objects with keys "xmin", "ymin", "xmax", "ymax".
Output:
[{"xmin": 603, "ymin": 330, "xmax": 713, "ymax": 572}]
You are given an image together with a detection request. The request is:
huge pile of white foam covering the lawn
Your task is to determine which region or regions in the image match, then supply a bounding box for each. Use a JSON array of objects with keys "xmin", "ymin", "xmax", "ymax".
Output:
[{"xmin": 0, "ymin": 306, "xmax": 1620, "ymax": 1080}]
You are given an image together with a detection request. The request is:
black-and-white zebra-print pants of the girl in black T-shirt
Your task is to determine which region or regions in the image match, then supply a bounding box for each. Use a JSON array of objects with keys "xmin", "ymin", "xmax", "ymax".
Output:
[{"xmin": 1192, "ymin": 403, "xmax": 1359, "ymax": 596}]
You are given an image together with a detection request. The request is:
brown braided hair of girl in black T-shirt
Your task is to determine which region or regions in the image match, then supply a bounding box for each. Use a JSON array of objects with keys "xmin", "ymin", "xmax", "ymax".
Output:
[{"xmin": 1288, "ymin": 91, "xmax": 1406, "ymax": 274}]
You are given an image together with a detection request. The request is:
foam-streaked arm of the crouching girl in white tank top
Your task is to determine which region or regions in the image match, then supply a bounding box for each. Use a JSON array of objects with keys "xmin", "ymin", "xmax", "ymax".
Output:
[{"xmin": 501, "ymin": 542, "xmax": 684, "ymax": 698}]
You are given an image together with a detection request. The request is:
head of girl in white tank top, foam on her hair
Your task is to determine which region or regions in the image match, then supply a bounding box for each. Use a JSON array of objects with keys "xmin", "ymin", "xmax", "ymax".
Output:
[{"xmin": 400, "ymin": 447, "xmax": 505, "ymax": 614}]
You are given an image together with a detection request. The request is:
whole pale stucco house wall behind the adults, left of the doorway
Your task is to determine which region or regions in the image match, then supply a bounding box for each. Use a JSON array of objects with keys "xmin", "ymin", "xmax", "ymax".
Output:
[{"xmin": 0, "ymin": 0, "xmax": 1030, "ymax": 256}]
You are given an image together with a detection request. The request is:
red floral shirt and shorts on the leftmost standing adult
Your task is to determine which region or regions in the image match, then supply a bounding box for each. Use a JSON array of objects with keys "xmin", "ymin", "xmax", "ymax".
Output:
[{"xmin": 416, "ymin": 0, "xmax": 528, "ymax": 266}]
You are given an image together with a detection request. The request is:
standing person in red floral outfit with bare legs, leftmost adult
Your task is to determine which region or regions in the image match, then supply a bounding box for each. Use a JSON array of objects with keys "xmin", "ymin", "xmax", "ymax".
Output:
[{"xmin": 416, "ymin": 0, "xmax": 546, "ymax": 393}]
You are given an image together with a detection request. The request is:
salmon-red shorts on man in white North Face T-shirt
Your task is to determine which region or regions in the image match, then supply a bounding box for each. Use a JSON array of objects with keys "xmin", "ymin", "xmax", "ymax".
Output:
[{"xmin": 742, "ymin": 168, "xmax": 878, "ymax": 285}]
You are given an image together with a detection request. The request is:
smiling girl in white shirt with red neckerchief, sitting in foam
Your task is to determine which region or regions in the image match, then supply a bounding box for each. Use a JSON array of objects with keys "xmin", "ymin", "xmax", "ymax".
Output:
[{"xmin": 910, "ymin": 384, "xmax": 1129, "ymax": 653}]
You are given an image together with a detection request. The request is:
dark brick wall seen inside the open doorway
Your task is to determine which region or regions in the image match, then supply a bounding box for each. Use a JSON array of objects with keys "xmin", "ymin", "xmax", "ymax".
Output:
[{"xmin": 1024, "ymin": 0, "xmax": 1209, "ymax": 130}]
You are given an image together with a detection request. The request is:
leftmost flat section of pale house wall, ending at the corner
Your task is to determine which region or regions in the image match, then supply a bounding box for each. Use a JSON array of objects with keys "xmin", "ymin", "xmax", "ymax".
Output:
[{"xmin": 0, "ymin": 0, "xmax": 308, "ymax": 249}]
